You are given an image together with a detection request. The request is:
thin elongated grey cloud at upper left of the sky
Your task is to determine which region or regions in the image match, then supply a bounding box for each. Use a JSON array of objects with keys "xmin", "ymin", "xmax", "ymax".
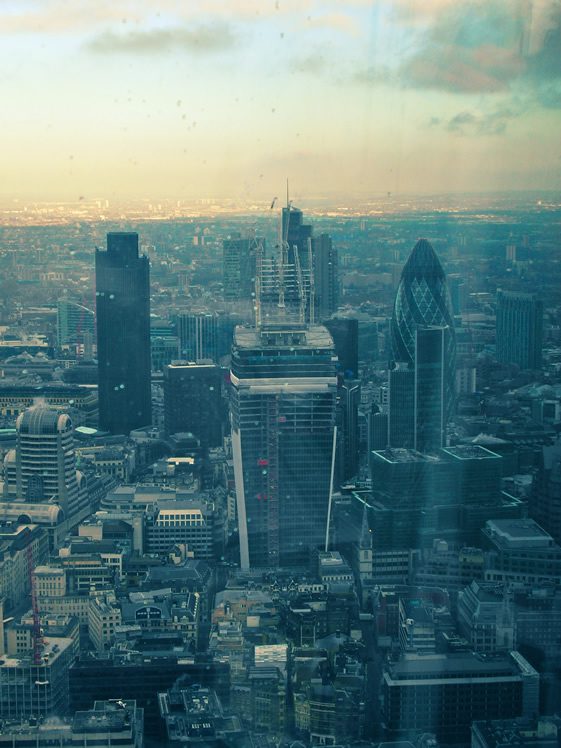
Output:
[{"xmin": 87, "ymin": 23, "xmax": 238, "ymax": 54}]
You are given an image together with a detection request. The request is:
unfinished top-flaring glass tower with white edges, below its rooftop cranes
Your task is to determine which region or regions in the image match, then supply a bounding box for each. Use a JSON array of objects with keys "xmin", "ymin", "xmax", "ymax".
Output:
[{"xmin": 231, "ymin": 323, "xmax": 337, "ymax": 569}]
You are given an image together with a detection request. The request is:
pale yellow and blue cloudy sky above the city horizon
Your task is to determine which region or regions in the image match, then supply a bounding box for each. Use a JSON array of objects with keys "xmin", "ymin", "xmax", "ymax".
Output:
[{"xmin": 0, "ymin": 0, "xmax": 561, "ymax": 201}]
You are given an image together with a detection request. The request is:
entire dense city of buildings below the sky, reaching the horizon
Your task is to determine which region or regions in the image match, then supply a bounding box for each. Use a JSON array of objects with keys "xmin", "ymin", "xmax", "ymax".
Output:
[{"xmin": 0, "ymin": 194, "xmax": 561, "ymax": 748}]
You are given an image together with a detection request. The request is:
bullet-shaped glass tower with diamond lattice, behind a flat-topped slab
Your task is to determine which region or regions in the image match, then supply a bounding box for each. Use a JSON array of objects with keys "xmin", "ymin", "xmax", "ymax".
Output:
[{"xmin": 391, "ymin": 239, "xmax": 456, "ymax": 421}]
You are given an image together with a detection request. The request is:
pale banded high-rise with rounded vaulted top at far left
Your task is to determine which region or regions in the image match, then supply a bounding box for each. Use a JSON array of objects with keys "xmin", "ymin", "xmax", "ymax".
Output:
[{"xmin": 16, "ymin": 405, "xmax": 90, "ymax": 524}]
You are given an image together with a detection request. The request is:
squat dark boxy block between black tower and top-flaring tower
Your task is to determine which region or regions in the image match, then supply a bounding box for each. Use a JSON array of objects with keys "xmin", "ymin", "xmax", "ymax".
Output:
[{"xmin": 164, "ymin": 362, "xmax": 224, "ymax": 448}]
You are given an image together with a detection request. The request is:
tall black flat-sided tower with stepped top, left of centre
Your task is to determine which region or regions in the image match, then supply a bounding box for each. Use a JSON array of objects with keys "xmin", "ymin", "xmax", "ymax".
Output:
[{"xmin": 95, "ymin": 232, "xmax": 152, "ymax": 434}]
